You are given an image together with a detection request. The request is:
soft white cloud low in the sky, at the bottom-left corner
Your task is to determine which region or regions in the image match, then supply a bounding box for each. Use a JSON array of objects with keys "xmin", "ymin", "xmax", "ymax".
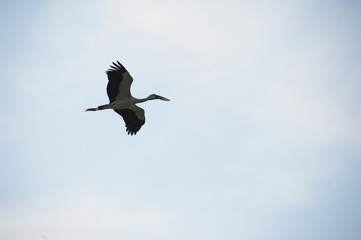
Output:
[{"xmin": 0, "ymin": 188, "xmax": 172, "ymax": 240}]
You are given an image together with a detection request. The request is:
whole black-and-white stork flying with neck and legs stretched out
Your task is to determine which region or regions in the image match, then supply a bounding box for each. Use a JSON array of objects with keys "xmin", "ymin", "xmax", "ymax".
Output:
[{"xmin": 85, "ymin": 61, "xmax": 170, "ymax": 136}]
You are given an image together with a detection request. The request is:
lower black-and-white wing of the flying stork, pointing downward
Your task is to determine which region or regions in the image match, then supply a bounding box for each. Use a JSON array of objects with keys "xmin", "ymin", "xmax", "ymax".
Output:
[{"xmin": 113, "ymin": 105, "xmax": 145, "ymax": 135}]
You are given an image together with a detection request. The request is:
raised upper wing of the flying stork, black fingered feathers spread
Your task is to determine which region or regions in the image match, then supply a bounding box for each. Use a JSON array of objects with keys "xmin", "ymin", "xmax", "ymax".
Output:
[{"xmin": 106, "ymin": 61, "xmax": 133, "ymax": 103}]
